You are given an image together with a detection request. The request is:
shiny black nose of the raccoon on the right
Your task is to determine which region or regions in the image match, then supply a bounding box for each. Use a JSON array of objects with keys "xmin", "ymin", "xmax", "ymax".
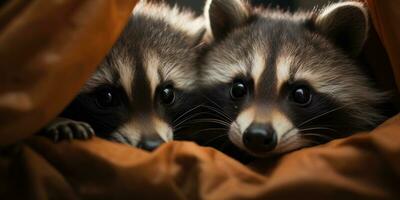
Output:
[{"xmin": 243, "ymin": 124, "xmax": 277, "ymax": 152}]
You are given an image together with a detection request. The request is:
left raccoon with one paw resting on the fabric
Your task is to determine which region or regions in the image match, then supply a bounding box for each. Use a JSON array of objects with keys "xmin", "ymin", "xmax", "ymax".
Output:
[{"xmin": 45, "ymin": 1, "xmax": 205, "ymax": 150}]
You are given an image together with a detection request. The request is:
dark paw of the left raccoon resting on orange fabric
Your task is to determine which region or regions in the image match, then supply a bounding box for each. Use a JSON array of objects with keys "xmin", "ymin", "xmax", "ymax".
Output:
[{"xmin": 42, "ymin": 118, "xmax": 95, "ymax": 142}]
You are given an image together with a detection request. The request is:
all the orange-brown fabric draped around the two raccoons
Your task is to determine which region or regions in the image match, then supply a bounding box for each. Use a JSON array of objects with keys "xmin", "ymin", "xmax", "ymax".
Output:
[{"xmin": 0, "ymin": 0, "xmax": 400, "ymax": 200}]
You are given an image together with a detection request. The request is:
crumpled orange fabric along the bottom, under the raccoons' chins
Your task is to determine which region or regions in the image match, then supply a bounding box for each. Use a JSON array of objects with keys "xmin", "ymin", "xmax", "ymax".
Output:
[{"xmin": 0, "ymin": 115, "xmax": 400, "ymax": 199}]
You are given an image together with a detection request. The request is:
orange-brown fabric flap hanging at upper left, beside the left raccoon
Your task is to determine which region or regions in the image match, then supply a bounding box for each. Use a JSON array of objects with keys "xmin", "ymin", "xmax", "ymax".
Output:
[{"xmin": 0, "ymin": 0, "xmax": 136, "ymax": 145}]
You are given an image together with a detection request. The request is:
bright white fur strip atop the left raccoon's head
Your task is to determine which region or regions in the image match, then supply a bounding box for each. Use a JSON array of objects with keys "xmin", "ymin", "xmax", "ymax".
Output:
[{"xmin": 132, "ymin": 0, "xmax": 205, "ymax": 36}]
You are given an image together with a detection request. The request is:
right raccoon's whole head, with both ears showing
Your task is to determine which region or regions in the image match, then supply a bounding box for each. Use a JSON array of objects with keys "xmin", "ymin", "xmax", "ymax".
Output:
[{"xmin": 202, "ymin": 0, "xmax": 381, "ymax": 157}]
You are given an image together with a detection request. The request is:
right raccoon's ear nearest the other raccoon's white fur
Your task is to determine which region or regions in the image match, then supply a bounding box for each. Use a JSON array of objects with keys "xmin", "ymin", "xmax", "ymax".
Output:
[{"xmin": 205, "ymin": 0, "xmax": 249, "ymax": 40}]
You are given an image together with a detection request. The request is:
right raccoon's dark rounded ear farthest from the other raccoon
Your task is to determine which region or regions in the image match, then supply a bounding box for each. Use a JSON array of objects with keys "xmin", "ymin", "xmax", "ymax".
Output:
[{"xmin": 314, "ymin": 2, "xmax": 369, "ymax": 57}]
